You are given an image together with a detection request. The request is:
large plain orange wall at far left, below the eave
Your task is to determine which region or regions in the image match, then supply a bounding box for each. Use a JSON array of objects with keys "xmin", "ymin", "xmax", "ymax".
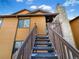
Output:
[{"xmin": 0, "ymin": 18, "xmax": 18, "ymax": 59}]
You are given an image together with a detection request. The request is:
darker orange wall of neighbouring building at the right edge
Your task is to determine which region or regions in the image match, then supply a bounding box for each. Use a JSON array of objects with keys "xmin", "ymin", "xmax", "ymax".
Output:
[{"xmin": 70, "ymin": 18, "xmax": 79, "ymax": 49}]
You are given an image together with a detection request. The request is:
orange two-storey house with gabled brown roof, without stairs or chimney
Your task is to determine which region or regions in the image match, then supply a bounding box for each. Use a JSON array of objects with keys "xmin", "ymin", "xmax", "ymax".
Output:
[{"xmin": 0, "ymin": 9, "xmax": 57, "ymax": 59}]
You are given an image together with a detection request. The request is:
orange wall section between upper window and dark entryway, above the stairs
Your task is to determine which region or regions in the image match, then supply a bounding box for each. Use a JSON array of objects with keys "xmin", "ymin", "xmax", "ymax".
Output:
[{"xmin": 30, "ymin": 16, "xmax": 46, "ymax": 34}]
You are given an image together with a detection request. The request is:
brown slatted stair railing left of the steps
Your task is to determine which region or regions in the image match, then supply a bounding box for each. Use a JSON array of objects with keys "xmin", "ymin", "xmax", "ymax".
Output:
[{"xmin": 12, "ymin": 26, "xmax": 37, "ymax": 59}]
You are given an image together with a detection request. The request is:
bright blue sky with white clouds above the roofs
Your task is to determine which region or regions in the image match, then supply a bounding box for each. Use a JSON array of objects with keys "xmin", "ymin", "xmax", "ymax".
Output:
[{"xmin": 0, "ymin": 0, "xmax": 79, "ymax": 19}]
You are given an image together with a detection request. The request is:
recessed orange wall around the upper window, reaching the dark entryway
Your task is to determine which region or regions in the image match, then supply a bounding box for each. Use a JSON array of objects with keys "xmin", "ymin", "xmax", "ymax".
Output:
[{"xmin": 16, "ymin": 16, "xmax": 46, "ymax": 41}]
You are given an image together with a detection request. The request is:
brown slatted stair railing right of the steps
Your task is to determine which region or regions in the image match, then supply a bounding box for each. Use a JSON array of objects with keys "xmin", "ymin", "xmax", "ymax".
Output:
[{"xmin": 48, "ymin": 24, "xmax": 79, "ymax": 59}]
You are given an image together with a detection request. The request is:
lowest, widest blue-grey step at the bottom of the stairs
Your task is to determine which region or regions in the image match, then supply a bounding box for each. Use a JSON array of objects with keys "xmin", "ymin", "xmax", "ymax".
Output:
[{"xmin": 31, "ymin": 53, "xmax": 58, "ymax": 59}]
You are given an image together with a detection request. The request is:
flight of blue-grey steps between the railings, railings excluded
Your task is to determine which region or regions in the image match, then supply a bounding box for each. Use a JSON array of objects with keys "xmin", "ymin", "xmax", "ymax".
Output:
[{"xmin": 31, "ymin": 36, "xmax": 58, "ymax": 59}]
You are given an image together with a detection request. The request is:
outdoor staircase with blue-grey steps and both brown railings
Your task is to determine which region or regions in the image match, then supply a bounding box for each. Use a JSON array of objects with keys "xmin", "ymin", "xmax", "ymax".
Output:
[{"xmin": 12, "ymin": 23, "xmax": 79, "ymax": 59}]
